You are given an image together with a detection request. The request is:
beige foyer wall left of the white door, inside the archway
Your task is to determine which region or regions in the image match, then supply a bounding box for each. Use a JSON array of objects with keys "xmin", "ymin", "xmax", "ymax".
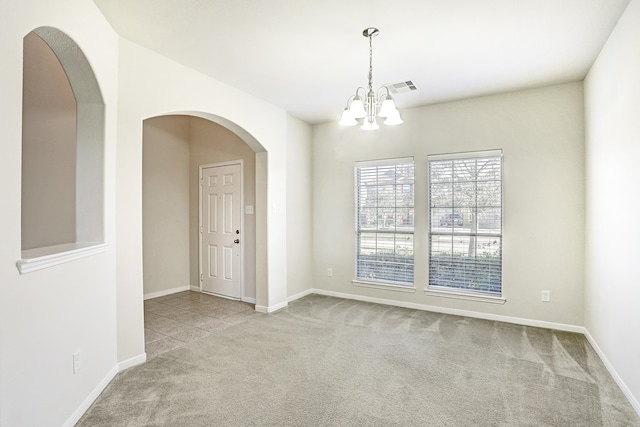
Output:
[{"xmin": 142, "ymin": 116, "xmax": 190, "ymax": 297}]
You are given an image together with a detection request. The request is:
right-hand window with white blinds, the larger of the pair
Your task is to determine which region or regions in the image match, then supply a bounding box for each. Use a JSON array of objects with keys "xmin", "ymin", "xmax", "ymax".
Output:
[{"xmin": 429, "ymin": 150, "xmax": 502, "ymax": 297}]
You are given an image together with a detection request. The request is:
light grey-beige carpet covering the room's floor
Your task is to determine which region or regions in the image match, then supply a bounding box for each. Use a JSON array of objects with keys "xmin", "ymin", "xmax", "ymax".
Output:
[{"xmin": 77, "ymin": 295, "xmax": 640, "ymax": 427}]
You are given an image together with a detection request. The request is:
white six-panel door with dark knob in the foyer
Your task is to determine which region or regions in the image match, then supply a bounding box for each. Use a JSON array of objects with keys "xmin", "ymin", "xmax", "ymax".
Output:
[{"xmin": 200, "ymin": 163, "xmax": 242, "ymax": 299}]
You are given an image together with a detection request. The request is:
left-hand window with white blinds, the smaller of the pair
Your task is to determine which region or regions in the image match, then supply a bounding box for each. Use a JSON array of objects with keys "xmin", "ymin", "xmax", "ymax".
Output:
[{"xmin": 354, "ymin": 158, "xmax": 414, "ymax": 287}]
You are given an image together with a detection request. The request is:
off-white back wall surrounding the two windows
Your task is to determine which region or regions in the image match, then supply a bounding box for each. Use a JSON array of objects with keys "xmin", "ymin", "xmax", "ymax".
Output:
[{"xmin": 313, "ymin": 83, "xmax": 584, "ymax": 327}]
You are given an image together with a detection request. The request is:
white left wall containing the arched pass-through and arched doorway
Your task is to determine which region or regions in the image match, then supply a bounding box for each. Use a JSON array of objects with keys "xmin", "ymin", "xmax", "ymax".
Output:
[{"xmin": 0, "ymin": 0, "xmax": 287, "ymax": 426}]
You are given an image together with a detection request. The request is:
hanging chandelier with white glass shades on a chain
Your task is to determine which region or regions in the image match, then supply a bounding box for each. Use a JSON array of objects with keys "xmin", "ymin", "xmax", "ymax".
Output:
[{"xmin": 339, "ymin": 27, "xmax": 402, "ymax": 130}]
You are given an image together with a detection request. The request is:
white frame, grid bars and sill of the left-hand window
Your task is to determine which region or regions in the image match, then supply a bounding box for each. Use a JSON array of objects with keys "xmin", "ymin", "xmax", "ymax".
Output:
[{"xmin": 352, "ymin": 157, "xmax": 416, "ymax": 292}]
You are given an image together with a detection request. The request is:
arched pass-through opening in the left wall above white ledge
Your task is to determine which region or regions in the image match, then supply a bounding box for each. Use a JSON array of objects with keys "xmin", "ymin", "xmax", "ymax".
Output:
[{"xmin": 18, "ymin": 27, "xmax": 105, "ymax": 273}]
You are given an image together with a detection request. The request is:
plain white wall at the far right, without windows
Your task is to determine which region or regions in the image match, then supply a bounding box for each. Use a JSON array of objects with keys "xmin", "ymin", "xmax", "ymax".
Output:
[{"xmin": 585, "ymin": 0, "xmax": 640, "ymax": 414}]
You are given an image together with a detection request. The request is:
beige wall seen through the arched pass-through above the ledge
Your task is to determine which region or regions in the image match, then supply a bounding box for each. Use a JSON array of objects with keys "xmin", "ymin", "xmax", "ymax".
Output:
[{"xmin": 22, "ymin": 33, "xmax": 76, "ymax": 250}]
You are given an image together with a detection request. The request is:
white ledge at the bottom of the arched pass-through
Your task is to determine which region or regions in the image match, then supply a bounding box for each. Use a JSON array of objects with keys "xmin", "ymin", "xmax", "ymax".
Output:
[{"xmin": 16, "ymin": 242, "xmax": 109, "ymax": 274}]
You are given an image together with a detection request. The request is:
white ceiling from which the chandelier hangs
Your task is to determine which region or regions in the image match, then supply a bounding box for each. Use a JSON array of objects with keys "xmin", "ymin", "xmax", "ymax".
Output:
[{"xmin": 94, "ymin": 0, "xmax": 629, "ymax": 123}]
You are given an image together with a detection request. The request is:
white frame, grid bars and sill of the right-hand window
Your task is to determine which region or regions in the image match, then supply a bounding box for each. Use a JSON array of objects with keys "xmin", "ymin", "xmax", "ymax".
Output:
[{"xmin": 424, "ymin": 149, "xmax": 506, "ymax": 304}]
